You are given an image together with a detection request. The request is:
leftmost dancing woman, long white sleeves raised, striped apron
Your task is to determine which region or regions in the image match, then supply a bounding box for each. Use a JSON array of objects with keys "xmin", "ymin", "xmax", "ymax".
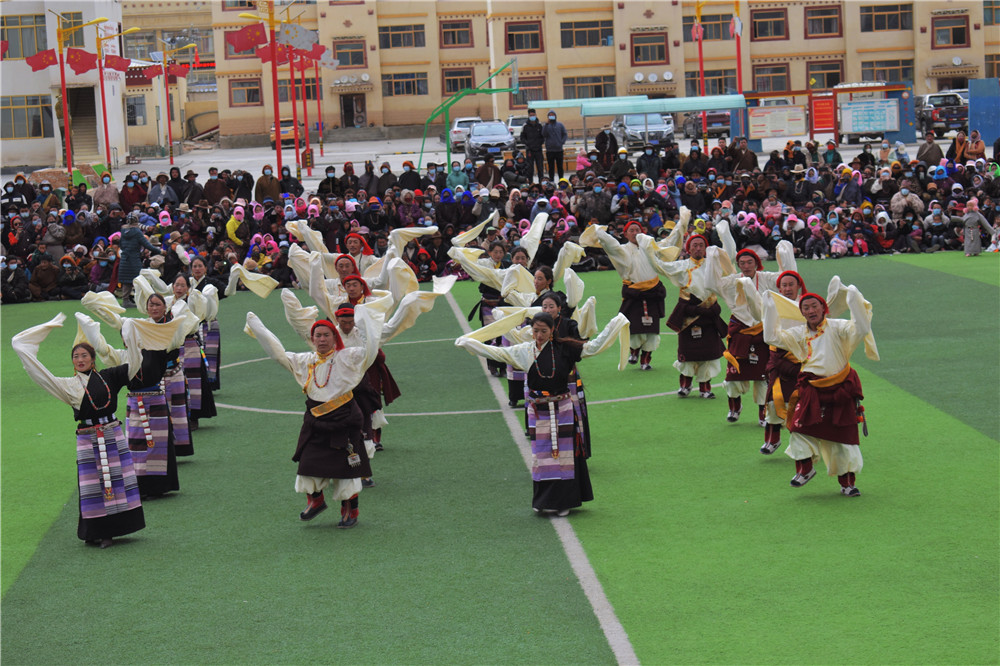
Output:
[{"xmin": 12, "ymin": 313, "xmax": 146, "ymax": 548}]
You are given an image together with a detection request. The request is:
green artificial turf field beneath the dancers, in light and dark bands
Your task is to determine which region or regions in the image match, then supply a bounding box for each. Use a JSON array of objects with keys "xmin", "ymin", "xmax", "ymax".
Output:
[{"xmin": 0, "ymin": 253, "xmax": 1000, "ymax": 664}]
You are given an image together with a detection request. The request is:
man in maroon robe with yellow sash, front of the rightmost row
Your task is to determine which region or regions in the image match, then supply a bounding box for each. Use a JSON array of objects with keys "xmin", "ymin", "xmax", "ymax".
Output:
[{"xmin": 762, "ymin": 278, "xmax": 878, "ymax": 497}]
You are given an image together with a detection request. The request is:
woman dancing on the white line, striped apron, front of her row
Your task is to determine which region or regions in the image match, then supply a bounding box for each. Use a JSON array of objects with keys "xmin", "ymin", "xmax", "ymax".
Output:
[{"xmin": 455, "ymin": 312, "xmax": 629, "ymax": 516}]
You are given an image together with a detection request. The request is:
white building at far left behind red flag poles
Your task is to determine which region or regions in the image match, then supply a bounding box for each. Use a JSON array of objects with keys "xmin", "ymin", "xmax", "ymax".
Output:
[{"xmin": 0, "ymin": 0, "xmax": 128, "ymax": 168}]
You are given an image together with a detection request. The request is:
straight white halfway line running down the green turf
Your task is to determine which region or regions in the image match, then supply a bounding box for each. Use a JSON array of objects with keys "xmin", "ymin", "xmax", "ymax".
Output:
[{"xmin": 446, "ymin": 293, "xmax": 639, "ymax": 664}]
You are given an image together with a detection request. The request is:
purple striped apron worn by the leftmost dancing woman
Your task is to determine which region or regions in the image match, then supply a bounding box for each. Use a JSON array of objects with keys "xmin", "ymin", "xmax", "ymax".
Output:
[{"xmin": 76, "ymin": 423, "xmax": 142, "ymax": 518}]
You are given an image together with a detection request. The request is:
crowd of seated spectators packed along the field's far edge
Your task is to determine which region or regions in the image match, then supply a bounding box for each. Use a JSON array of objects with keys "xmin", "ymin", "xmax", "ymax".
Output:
[{"xmin": 0, "ymin": 126, "xmax": 1000, "ymax": 304}]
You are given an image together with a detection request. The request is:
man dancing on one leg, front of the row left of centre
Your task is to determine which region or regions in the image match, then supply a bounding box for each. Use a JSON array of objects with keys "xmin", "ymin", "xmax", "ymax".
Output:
[{"xmin": 245, "ymin": 305, "xmax": 385, "ymax": 528}]
